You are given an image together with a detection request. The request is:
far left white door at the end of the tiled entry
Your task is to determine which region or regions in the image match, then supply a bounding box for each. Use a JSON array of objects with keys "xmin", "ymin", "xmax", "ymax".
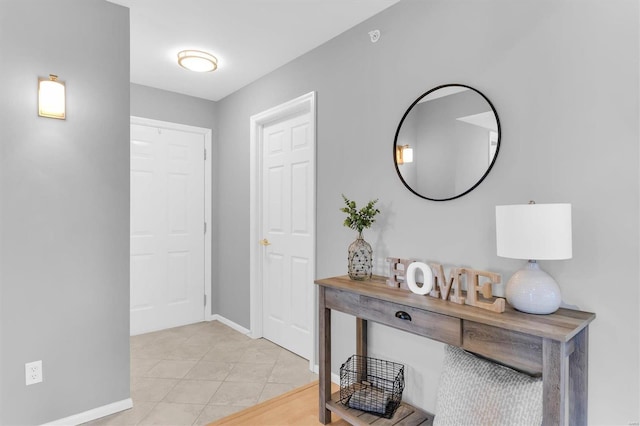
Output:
[{"xmin": 130, "ymin": 123, "xmax": 205, "ymax": 335}]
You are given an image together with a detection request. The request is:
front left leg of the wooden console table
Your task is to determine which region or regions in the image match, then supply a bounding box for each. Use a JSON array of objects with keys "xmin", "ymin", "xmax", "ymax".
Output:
[{"xmin": 318, "ymin": 287, "xmax": 331, "ymax": 425}]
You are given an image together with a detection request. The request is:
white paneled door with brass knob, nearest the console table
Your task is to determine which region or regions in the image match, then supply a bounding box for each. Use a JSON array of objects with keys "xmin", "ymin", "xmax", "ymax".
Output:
[{"xmin": 256, "ymin": 106, "xmax": 315, "ymax": 359}]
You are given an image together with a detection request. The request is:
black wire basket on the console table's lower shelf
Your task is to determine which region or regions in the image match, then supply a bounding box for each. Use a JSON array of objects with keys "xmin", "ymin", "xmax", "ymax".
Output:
[{"xmin": 340, "ymin": 355, "xmax": 404, "ymax": 419}]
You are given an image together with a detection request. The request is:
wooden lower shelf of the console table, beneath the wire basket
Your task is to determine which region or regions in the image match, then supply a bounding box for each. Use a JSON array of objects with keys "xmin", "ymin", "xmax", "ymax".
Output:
[{"xmin": 327, "ymin": 391, "xmax": 434, "ymax": 426}]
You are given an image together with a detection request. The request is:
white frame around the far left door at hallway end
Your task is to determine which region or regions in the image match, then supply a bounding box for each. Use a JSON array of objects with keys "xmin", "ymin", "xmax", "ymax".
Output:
[{"xmin": 130, "ymin": 115, "xmax": 214, "ymax": 321}]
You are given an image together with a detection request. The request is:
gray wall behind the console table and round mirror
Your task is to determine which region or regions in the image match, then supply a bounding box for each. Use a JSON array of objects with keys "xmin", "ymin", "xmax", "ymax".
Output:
[{"xmin": 218, "ymin": 0, "xmax": 640, "ymax": 424}]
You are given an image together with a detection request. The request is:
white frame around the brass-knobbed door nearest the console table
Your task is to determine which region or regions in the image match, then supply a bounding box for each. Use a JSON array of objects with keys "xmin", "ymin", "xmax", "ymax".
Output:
[{"xmin": 249, "ymin": 91, "xmax": 318, "ymax": 367}]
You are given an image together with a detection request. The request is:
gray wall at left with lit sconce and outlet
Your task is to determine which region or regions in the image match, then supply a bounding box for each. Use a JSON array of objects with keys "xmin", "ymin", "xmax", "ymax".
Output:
[{"xmin": 0, "ymin": 0, "xmax": 129, "ymax": 425}]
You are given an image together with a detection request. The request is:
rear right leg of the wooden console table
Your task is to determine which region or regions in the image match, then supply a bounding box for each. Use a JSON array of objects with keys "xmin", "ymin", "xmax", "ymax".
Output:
[{"xmin": 569, "ymin": 326, "xmax": 589, "ymax": 425}]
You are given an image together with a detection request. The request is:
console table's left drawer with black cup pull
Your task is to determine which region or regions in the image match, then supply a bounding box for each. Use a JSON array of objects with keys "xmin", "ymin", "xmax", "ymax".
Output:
[{"xmin": 326, "ymin": 289, "xmax": 462, "ymax": 346}]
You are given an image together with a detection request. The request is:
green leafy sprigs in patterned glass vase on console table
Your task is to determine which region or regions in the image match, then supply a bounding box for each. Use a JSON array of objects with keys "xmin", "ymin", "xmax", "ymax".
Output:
[{"xmin": 340, "ymin": 194, "xmax": 380, "ymax": 281}]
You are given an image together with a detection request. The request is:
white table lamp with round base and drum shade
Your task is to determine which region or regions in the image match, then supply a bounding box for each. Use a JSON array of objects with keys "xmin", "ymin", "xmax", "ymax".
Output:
[{"xmin": 496, "ymin": 202, "xmax": 572, "ymax": 314}]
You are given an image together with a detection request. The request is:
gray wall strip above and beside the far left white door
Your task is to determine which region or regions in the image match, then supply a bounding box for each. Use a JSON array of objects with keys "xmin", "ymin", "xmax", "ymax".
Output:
[{"xmin": 131, "ymin": 83, "xmax": 221, "ymax": 314}]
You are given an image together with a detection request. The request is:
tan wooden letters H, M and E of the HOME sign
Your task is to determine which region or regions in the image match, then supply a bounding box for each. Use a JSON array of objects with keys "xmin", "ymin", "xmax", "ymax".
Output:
[{"xmin": 387, "ymin": 257, "xmax": 505, "ymax": 313}]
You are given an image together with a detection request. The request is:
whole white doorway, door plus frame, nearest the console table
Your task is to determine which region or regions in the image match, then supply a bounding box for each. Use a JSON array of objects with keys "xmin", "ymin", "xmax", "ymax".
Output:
[{"xmin": 250, "ymin": 92, "xmax": 316, "ymax": 363}]
